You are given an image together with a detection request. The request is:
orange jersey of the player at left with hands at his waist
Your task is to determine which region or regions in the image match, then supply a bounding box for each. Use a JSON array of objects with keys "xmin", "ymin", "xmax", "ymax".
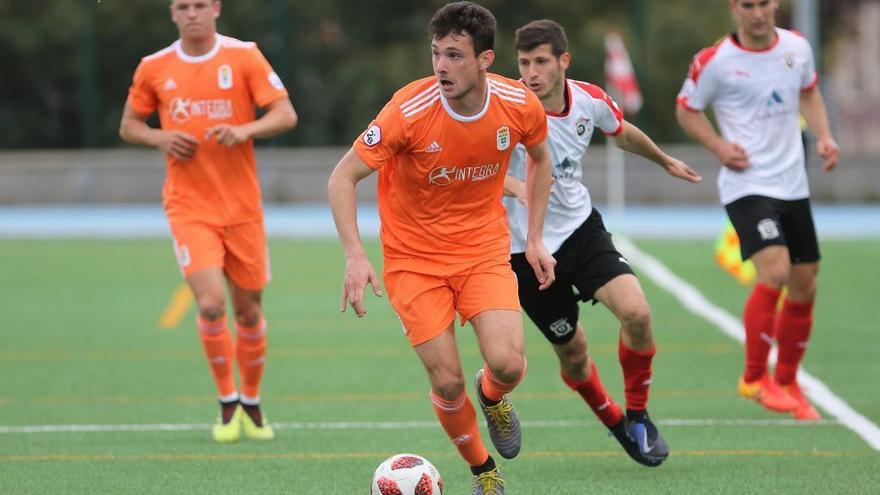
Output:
[{"xmin": 128, "ymin": 34, "xmax": 287, "ymax": 225}]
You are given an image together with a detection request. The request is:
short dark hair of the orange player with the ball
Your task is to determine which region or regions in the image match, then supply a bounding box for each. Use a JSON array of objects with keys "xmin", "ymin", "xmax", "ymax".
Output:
[{"xmin": 428, "ymin": 2, "xmax": 498, "ymax": 55}]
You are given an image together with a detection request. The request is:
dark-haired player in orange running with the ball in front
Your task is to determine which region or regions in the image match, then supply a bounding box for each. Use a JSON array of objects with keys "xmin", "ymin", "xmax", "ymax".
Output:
[{"xmin": 328, "ymin": 2, "xmax": 555, "ymax": 495}]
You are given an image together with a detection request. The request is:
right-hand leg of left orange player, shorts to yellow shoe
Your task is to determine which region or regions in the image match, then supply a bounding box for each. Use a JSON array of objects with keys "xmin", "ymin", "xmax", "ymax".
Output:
[{"xmin": 224, "ymin": 222, "xmax": 274, "ymax": 440}]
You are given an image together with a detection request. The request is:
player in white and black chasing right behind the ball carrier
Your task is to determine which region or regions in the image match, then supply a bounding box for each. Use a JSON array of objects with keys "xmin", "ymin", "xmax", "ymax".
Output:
[{"xmin": 504, "ymin": 20, "xmax": 701, "ymax": 466}]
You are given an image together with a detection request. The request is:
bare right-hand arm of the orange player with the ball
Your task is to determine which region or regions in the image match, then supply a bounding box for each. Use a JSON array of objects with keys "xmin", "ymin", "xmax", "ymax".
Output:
[{"xmin": 526, "ymin": 140, "xmax": 556, "ymax": 290}]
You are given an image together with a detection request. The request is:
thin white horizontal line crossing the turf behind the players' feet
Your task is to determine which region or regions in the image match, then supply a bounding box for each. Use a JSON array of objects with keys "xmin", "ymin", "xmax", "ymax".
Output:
[{"xmin": 0, "ymin": 419, "xmax": 838, "ymax": 434}]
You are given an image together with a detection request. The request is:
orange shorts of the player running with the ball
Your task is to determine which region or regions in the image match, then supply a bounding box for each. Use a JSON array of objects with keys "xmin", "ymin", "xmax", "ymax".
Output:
[{"xmin": 382, "ymin": 257, "xmax": 520, "ymax": 346}]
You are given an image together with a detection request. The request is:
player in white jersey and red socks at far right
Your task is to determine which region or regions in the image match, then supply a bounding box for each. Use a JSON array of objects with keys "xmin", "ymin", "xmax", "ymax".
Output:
[{"xmin": 676, "ymin": 0, "xmax": 838, "ymax": 420}]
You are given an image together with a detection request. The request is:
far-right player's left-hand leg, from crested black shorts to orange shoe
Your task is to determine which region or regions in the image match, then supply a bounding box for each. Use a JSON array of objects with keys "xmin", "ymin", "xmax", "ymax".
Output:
[{"xmin": 725, "ymin": 196, "xmax": 797, "ymax": 412}]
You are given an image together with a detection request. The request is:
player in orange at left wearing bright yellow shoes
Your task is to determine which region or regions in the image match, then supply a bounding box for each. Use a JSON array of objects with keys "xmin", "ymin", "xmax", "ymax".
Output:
[{"xmin": 119, "ymin": 0, "xmax": 297, "ymax": 442}]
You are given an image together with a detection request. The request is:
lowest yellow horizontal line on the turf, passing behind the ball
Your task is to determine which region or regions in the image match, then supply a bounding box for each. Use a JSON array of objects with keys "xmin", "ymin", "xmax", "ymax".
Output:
[{"xmin": 0, "ymin": 449, "xmax": 877, "ymax": 462}]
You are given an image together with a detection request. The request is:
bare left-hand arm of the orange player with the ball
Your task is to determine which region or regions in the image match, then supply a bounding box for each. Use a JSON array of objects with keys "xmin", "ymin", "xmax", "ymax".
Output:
[{"xmin": 327, "ymin": 148, "xmax": 382, "ymax": 317}]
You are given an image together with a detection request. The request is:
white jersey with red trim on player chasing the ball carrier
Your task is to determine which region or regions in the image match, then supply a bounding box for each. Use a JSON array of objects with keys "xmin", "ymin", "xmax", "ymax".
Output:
[{"xmin": 504, "ymin": 79, "xmax": 623, "ymax": 253}]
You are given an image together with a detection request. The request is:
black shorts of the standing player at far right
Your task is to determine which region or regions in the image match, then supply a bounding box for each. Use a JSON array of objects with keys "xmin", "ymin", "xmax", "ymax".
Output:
[{"xmin": 724, "ymin": 196, "xmax": 820, "ymax": 264}]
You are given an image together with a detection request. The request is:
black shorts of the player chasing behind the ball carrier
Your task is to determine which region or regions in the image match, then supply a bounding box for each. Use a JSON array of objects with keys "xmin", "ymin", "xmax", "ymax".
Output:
[{"xmin": 510, "ymin": 208, "xmax": 633, "ymax": 345}]
